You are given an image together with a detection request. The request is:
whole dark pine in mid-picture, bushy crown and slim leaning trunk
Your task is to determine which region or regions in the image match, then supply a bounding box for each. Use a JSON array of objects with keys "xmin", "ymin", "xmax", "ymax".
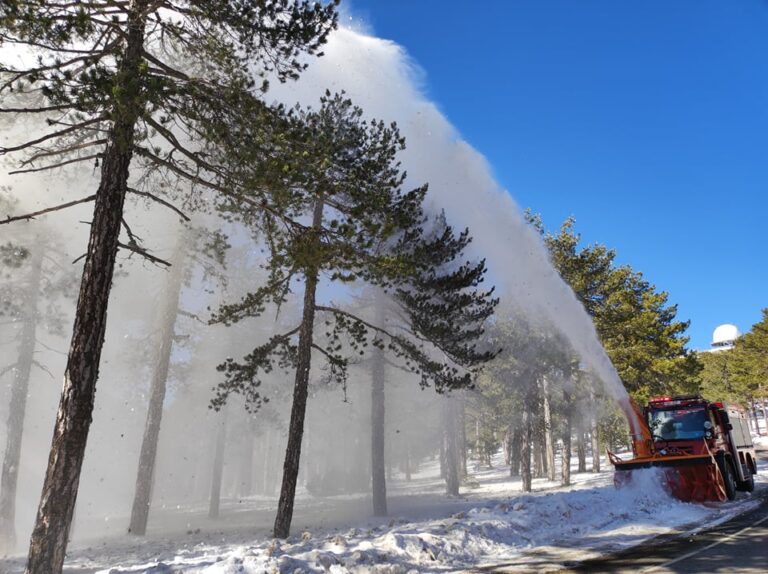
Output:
[{"xmin": 213, "ymin": 93, "xmax": 492, "ymax": 538}]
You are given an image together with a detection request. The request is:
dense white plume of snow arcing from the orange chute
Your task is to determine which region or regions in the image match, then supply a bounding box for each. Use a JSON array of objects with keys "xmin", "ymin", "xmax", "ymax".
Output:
[{"xmin": 273, "ymin": 28, "xmax": 636, "ymax": 431}]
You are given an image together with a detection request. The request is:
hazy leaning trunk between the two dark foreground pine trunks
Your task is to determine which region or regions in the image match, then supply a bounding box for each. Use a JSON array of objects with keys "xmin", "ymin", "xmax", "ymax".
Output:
[{"xmin": 128, "ymin": 237, "xmax": 187, "ymax": 536}]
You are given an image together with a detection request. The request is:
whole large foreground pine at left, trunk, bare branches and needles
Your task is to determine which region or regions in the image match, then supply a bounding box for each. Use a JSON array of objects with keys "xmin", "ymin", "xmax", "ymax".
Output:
[{"xmin": 0, "ymin": 0, "xmax": 336, "ymax": 574}]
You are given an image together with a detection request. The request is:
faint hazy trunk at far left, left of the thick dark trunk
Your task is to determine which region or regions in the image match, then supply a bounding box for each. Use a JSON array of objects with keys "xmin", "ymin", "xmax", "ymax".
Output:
[{"xmin": 0, "ymin": 244, "xmax": 43, "ymax": 554}]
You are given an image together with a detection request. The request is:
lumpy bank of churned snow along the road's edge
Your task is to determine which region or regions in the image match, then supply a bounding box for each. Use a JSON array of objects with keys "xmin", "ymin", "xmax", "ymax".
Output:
[{"xmin": 46, "ymin": 469, "xmax": 756, "ymax": 574}]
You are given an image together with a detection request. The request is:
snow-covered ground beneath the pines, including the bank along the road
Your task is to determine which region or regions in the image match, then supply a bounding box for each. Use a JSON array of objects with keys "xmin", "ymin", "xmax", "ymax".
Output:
[{"xmin": 0, "ymin": 448, "xmax": 768, "ymax": 574}]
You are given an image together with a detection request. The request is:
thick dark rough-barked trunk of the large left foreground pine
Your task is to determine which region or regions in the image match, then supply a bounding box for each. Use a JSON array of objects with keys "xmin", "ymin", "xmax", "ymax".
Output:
[{"xmin": 26, "ymin": 5, "xmax": 149, "ymax": 574}]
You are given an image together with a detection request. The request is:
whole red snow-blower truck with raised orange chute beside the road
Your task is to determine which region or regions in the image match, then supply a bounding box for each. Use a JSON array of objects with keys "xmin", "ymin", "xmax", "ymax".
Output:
[{"xmin": 608, "ymin": 396, "xmax": 757, "ymax": 502}]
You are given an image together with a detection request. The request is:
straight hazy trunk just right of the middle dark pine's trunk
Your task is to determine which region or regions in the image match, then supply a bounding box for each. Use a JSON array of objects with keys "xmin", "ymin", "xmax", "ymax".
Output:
[{"xmin": 371, "ymin": 301, "xmax": 387, "ymax": 516}]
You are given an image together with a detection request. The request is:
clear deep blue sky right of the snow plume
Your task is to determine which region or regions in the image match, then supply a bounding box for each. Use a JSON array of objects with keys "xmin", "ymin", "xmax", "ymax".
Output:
[{"xmin": 352, "ymin": 0, "xmax": 768, "ymax": 349}]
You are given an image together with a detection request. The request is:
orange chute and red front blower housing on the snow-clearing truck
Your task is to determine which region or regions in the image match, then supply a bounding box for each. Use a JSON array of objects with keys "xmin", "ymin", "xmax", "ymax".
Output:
[{"xmin": 607, "ymin": 401, "xmax": 727, "ymax": 502}]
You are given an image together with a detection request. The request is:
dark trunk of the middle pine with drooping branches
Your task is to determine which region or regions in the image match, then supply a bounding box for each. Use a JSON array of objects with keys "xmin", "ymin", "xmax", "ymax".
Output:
[{"xmin": 274, "ymin": 199, "xmax": 323, "ymax": 538}]
